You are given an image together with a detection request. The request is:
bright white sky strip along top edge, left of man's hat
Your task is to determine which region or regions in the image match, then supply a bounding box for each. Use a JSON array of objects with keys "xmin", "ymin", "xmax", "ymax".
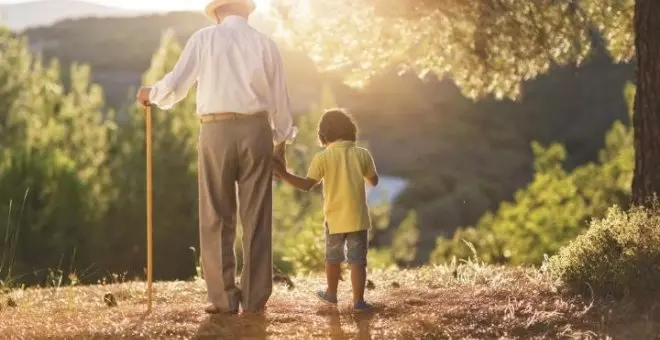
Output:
[{"xmin": 0, "ymin": 0, "xmax": 270, "ymax": 11}]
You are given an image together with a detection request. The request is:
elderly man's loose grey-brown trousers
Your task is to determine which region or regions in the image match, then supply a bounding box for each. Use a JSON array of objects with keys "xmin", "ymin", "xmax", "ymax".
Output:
[{"xmin": 199, "ymin": 116, "xmax": 273, "ymax": 312}]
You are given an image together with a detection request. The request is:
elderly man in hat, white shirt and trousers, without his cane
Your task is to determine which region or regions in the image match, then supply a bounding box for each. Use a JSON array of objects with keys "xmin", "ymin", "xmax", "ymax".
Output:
[{"xmin": 137, "ymin": 0, "xmax": 296, "ymax": 313}]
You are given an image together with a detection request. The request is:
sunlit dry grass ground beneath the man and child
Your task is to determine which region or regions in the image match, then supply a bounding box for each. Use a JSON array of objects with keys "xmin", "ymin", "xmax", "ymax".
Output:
[{"xmin": 0, "ymin": 264, "xmax": 660, "ymax": 339}]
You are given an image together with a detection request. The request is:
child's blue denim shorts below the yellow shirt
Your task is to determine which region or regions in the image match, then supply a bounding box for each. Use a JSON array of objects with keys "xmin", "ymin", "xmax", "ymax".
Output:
[{"xmin": 325, "ymin": 226, "xmax": 369, "ymax": 266}]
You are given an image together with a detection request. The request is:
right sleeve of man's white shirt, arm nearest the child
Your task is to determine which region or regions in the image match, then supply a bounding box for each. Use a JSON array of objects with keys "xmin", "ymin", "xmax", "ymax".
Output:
[{"xmin": 269, "ymin": 41, "xmax": 298, "ymax": 144}]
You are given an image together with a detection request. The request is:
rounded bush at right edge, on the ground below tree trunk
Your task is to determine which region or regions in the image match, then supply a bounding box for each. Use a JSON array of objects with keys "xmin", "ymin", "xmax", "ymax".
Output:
[{"xmin": 548, "ymin": 202, "xmax": 660, "ymax": 297}]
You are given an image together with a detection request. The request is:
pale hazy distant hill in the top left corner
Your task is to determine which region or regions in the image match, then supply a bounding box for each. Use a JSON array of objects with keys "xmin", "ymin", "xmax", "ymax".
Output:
[{"xmin": 0, "ymin": 0, "xmax": 139, "ymax": 31}]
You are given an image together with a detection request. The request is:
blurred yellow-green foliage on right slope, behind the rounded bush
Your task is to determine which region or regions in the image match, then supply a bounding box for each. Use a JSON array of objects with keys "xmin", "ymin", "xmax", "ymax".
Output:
[{"xmin": 431, "ymin": 83, "xmax": 634, "ymax": 264}]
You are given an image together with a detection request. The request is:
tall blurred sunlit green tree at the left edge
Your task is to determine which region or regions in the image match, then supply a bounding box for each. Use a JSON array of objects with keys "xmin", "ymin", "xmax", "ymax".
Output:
[{"xmin": 0, "ymin": 27, "xmax": 114, "ymax": 282}]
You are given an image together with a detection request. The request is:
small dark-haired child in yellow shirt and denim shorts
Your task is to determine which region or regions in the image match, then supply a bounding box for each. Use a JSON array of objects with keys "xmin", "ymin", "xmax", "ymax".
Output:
[{"xmin": 275, "ymin": 109, "xmax": 378, "ymax": 311}]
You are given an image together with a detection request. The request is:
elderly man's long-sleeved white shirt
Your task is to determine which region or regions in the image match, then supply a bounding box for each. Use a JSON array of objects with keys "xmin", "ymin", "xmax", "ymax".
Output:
[{"xmin": 149, "ymin": 16, "xmax": 297, "ymax": 143}]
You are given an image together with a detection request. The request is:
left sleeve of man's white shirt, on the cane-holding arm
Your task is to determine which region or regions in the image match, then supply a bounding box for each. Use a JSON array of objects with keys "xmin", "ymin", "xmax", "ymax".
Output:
[{"xmin": 149, "ymin": 34, "xmax": 201, "ymax": 110}]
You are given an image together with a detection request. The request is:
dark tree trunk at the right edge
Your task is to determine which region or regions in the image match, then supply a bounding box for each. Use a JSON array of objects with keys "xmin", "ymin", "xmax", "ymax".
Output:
[{"xmin": 632, "ymin": 0, "xmax": 660, "ymax": 205}]
